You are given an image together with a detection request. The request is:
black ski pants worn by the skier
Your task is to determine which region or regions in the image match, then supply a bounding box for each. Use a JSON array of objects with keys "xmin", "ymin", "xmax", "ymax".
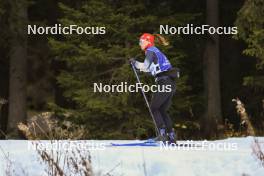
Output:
[{"xmin": 150, "ymin": 77, "xmax": 176, "ymax": 133}]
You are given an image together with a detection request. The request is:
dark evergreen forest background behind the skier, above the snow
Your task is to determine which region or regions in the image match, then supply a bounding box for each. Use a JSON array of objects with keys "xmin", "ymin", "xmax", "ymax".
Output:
[{"xmin": 0, "ymin": 0, "xmax": 264, "ymax": 140}]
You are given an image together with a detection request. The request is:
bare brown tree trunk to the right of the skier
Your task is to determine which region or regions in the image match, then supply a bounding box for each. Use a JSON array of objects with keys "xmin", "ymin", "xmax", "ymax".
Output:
[{"xmin": 202, "ymin": 0, "xmax": 222, "ymax": 137}]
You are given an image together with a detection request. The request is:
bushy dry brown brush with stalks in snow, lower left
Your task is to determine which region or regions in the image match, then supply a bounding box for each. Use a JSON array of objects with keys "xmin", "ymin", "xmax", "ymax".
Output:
[{"xmin": 18, "ymin": 112, "xmax": 93, "ymax": 176}]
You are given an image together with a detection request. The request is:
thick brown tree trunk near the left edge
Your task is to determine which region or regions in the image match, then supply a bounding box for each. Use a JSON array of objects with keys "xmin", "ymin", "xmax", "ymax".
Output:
[{"xmin": 7, "ymin": 0, "xmax": 27, "ymax": 138}]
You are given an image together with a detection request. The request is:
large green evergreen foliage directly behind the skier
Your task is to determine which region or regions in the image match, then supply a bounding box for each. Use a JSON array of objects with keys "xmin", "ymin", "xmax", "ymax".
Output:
[{"xmin": 49, "ymin": 0, "xmax": 198, "ymax": 138}]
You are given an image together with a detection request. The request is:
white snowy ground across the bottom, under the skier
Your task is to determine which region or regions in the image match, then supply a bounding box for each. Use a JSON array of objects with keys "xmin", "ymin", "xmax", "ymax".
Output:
[{"xmin": 0, "ymin": 137, "xmax": 264, "ymax": 176}]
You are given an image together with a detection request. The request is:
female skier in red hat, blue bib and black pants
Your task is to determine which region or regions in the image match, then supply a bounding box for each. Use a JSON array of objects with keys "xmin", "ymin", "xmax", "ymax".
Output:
[{"xmin": 130, "ymin": 33, "xmax": 179, "ymax": 143}]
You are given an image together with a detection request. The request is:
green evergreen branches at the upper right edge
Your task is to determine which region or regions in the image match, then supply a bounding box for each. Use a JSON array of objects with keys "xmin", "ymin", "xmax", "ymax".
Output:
[{"xmin": 235, "ymin": 0, "xmax": 264, "ymax": 89}]
